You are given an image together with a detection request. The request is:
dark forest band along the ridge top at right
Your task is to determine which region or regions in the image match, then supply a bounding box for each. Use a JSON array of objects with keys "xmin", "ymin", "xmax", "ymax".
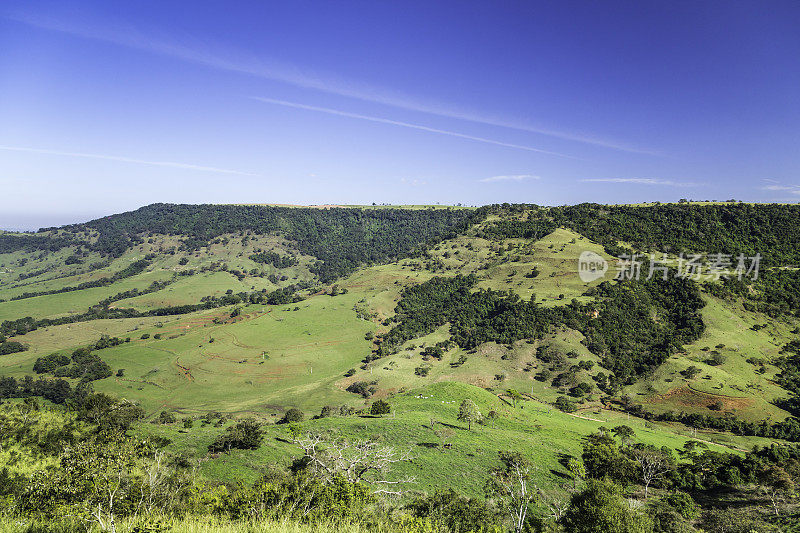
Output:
[{"xmin": 478, "ymin": 203, "xmax": 800, "ymax": 265}]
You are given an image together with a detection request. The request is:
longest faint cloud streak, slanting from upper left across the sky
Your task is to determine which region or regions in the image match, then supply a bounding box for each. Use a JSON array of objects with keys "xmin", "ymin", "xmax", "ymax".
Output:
[{"xmin": 6, "ymin": 12, "xmax": 657, "ymax": 155}]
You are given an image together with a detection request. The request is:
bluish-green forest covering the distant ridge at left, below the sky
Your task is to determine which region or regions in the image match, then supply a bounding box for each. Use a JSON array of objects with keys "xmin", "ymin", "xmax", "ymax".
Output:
[{"xmin": 12, "ymin": 204, "xmax": 484, "ymax": 283}]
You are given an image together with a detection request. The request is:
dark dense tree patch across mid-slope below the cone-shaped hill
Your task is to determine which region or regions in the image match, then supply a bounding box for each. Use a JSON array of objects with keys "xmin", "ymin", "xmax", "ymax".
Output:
[{"xmin": 375, "ymin": 275, "xmax": 704, "ymax": 390}]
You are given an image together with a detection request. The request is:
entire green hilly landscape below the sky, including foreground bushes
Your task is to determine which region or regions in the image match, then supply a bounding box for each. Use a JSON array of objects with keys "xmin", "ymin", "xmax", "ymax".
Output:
[{"xmin": 0, "ymin": 203, "xmax": 800, "ymax": 533}]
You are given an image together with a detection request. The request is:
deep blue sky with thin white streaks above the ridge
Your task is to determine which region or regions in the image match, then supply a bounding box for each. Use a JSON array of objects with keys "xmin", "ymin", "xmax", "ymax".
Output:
[{"xmin": 0, "ymin": 0, "xmax": 800, "ymax": 228}]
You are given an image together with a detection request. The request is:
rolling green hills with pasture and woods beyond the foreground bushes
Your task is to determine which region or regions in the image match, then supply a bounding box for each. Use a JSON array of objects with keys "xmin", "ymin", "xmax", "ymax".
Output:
[{"xmin": 0, "ymin": 204, "xmax": 800, "ymax": 528}]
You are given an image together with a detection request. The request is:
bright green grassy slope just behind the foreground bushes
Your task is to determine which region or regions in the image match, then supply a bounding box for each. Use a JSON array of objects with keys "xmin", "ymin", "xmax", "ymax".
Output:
[{"xmin": 139, "ymin": 382, "xmax": 768, "ymax": 496}]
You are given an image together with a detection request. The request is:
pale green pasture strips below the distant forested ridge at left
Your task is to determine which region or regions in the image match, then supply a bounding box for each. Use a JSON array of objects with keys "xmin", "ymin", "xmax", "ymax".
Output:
[{"xmin": 0, "ymin": 235, "xmax": 313, "ymax": 321}]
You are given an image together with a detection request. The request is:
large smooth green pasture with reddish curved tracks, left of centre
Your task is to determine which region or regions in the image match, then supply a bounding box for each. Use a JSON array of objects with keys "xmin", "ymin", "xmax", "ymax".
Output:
[{"xmin": 87, "ymin": 294, "xmax": 373, "ymax": 415}]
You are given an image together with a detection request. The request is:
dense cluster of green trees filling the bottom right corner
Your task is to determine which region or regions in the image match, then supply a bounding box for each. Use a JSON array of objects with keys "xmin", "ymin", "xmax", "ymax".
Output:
[{"xmin": 580, "ymin": 425, "xmax": 800, "ymax": 533}]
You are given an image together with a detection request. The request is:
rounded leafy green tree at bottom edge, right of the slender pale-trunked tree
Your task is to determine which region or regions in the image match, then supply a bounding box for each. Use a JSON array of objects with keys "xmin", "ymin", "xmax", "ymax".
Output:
[{"xmin": 560, "ymin": 479, "xmax": 653, "ymax": 533}]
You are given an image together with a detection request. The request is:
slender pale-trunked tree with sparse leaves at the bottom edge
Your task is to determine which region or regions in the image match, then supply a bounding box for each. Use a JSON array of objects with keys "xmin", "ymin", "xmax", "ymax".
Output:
[{"xmin": 485, "ymin": 452, "xmax": 536, "ymax": 533}]
